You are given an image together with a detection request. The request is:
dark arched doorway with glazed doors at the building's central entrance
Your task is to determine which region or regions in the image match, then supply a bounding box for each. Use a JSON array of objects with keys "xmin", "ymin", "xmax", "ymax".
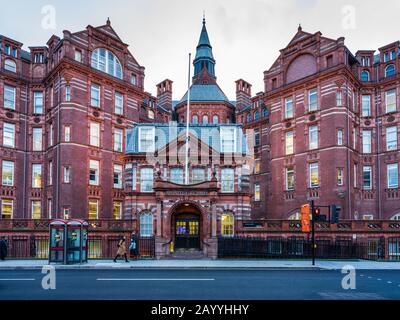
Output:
[{"xmin": 172, "ymin": 203, "xmax": 202, "ymax": 250}]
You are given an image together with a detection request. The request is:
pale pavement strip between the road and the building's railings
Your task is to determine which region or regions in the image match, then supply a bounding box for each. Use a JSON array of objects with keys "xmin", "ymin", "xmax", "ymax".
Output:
[{"xmin": 0, "ymin": 259, "xmax": 400, "ymax": 271}]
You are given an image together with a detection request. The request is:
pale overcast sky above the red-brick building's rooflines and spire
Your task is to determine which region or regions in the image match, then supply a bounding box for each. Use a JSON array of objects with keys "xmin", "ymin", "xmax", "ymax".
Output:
[{"xmin": 0, "ymin": 0, "xmax": 400, "ymax": 100}]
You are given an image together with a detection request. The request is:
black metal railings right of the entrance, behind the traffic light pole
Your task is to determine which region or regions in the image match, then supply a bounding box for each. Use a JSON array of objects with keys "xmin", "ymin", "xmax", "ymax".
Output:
[{"xmin": 218, "ymin": 237, "xmax": 386, "ymax": 260}]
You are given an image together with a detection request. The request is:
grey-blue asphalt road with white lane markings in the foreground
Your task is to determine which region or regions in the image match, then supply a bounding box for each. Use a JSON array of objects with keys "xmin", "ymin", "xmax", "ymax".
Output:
[{"xmin": 0, "ymin": 269, "xmax": 400, "ymax": 301}]
